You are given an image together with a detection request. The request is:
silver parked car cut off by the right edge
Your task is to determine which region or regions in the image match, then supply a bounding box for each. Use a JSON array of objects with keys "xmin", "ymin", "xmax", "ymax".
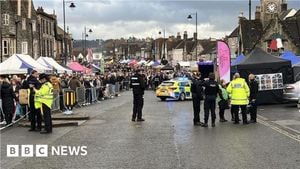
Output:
[{"xmin": 283, "ymin": 81, "xmax": 300, "ymax": 103}]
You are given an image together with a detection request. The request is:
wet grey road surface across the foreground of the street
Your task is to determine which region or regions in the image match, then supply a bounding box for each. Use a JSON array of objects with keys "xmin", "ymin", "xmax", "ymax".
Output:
[{"xmin": 0, "ymin": 91, "xmax": 300, "ymax": 169}]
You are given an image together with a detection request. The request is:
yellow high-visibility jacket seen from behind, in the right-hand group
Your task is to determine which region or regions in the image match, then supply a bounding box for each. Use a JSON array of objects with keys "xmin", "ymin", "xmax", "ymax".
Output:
[{"xmin": 226, "ymin": 78, "xmax": 250, "ymax": 105}]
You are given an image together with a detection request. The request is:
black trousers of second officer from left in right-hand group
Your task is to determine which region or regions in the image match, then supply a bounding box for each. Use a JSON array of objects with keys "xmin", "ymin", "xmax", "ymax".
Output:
[{"xmin": 204, "ymin": 96, "xmax": 216, "ymax": 124}]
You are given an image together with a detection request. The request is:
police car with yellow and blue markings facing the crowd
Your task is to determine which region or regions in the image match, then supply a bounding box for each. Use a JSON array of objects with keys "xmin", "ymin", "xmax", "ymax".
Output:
[{"xmin": 156, "ymin": 78, "xmax": 192, "ymax": 101}]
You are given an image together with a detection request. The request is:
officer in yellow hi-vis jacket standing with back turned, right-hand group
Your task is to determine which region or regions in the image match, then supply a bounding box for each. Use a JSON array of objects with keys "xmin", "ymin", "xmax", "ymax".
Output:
[{"xmin": 226, "ymin": 73, "xmax": 250, "ymax": 124}]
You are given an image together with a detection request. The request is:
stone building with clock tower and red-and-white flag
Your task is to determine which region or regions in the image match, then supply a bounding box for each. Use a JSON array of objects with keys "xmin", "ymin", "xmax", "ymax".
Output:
[{"xmin": 227, "ymin": 0, "xmax": 300, "ymax": 56}]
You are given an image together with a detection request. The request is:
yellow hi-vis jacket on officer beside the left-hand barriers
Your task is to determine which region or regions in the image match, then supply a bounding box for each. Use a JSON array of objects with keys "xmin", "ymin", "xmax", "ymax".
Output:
[{"xmin": 34, "ymin": 82, "xmax": 53, "ymax": 109}]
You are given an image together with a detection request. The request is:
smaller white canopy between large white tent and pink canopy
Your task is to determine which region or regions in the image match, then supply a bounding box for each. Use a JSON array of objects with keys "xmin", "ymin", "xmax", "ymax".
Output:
[{"xmin": 37, "ymin": 57, "xmax": 72, "ymax": 74}]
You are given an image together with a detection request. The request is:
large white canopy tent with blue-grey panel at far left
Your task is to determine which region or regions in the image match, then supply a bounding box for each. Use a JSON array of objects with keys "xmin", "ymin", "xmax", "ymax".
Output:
[{"xmin": 0, "ymin": 54, "xmax": 51, "ymax": 75}]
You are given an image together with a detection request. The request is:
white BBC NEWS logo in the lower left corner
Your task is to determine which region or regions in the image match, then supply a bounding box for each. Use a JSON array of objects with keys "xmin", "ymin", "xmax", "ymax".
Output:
[{"xmin": 6, "ymin": 145, "xmax": 87, "ymax": 157}]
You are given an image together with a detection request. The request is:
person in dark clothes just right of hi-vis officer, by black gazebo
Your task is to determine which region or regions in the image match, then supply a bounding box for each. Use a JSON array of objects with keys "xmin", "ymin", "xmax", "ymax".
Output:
[{"xmin": 249, "ymin": 74, "xmax": 258, "ymax": 123}]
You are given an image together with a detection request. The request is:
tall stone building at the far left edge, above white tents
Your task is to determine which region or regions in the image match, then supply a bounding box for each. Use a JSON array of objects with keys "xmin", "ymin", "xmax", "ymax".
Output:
[{"xmin": 0, "ymin": 0, "xmax": 38, "ymax": 61}]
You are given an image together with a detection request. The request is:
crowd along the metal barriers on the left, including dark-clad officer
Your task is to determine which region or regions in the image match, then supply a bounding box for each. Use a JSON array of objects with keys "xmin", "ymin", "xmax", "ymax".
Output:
[{"xmin": 0, "ymin": 66, "xmax": 185, "ymax": 130}]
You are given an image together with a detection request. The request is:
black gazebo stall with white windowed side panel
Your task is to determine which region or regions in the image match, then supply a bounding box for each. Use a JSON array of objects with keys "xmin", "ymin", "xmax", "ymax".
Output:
[{"xmin": 237, "ymin": 48, "xmax": 293, "ymax": 104}]
